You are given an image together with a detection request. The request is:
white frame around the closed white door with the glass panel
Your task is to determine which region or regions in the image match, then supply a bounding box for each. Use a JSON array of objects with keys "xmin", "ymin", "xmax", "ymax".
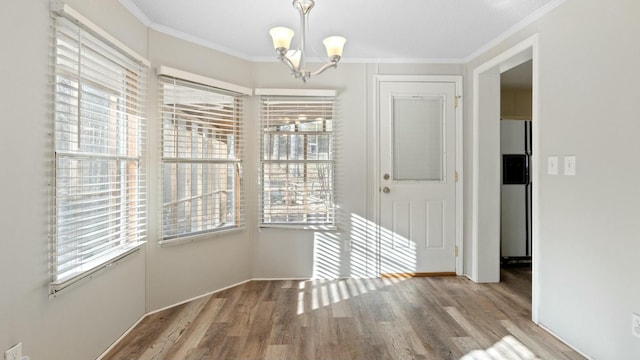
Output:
[{"xmin": 373, "ymin": 75, "xmax": 464, "ymax": 275}]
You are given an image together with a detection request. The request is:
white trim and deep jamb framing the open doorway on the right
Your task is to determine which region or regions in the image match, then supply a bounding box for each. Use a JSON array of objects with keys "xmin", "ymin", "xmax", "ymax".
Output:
[{"xmin": 470, "ymin": 35, "xmax": 540, "ymax": 323}]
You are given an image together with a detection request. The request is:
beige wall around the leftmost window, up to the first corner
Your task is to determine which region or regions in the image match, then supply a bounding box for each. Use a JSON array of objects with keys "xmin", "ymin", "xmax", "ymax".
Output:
[{"xmin": 0, "ymin": 0, "xmax": 146, "ymax": 360}]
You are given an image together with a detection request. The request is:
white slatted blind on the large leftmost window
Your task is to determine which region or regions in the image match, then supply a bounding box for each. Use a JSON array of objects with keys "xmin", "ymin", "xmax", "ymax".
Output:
[{"xmin": 50, "ymin": 8, "xmax": 147, "ymax": 294}]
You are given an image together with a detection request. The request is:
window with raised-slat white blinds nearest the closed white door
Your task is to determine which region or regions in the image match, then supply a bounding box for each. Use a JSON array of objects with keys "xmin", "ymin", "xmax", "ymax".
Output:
[{"xmin": 260, "ymin": 96, "xmax": 336, "ymax": 227}]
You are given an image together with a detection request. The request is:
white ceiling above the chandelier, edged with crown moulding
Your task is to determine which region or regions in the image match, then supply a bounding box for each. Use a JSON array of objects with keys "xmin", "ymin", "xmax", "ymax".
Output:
[{"xmin": 120, "ymin": 0, "xmax": 563, "ymax": 62}]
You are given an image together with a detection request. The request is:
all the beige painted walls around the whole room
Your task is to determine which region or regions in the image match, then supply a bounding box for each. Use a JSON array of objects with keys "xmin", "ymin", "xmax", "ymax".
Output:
[{"xmin": 0, "ymin": 0, "xmax": 640, "ymax": 360}]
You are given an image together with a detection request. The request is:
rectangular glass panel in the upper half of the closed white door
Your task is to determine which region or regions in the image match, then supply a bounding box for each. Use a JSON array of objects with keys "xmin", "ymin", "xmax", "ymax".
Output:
[{"xmin": 393, "ymin": 97, "xmax": 444, "ymax": 181}]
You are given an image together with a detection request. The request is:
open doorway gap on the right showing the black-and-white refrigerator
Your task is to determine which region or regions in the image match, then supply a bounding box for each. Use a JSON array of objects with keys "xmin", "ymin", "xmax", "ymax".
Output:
[{"xmin": 500, "ymin": 60, "xmax": 533, "ymax": 301}]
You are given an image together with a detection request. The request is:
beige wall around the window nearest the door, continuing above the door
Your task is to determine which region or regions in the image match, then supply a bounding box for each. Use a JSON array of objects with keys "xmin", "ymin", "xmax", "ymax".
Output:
[{"xmin": 251, "ymin": 63, "xmax": 463, "ymax": 278}]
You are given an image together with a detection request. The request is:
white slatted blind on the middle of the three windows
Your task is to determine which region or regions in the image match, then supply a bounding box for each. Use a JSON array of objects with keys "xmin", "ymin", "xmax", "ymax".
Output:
[{"xmin": 160, "ymin": 76, "xmax": 244, "ymax": 243}]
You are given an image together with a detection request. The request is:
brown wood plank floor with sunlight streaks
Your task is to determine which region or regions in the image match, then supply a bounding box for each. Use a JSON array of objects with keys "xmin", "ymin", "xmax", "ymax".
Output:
[{"xmin": 103, "ymin": 268, "xmax": 583, "ymax": 360}]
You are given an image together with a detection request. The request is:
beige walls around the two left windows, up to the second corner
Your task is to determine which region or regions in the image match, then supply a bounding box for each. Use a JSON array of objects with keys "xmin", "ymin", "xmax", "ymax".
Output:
[{"xmin": 0, "ymin": 0, "xmax": 252, "ymax": 360}]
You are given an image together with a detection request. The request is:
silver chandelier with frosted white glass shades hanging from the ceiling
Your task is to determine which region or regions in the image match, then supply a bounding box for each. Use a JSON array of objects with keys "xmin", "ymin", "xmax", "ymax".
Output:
[{"xmin": 269, "ymin": 0, "xmax": 347, "ymax": 82}]
